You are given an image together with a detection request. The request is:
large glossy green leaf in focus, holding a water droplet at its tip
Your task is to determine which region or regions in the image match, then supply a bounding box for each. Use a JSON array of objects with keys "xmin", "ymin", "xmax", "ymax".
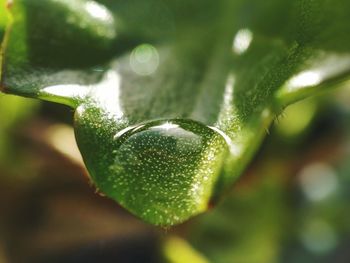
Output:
[{"xmin": 1, "ymin": 0, "xmax": 350, "ymax": 226}]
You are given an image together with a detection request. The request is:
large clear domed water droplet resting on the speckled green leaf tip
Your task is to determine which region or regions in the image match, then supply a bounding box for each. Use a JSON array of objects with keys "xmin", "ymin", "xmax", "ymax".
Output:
[{"xmin": 77, "ymin": 116, "xmax": 230, "ymax": 226}]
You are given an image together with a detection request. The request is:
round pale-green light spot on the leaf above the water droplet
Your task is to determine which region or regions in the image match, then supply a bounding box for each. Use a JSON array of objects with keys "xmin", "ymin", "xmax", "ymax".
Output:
[{"xmin": 130, "ymin": 44, "xmax": 159, "ymax": 76}]
